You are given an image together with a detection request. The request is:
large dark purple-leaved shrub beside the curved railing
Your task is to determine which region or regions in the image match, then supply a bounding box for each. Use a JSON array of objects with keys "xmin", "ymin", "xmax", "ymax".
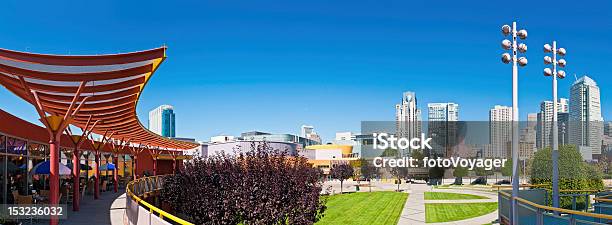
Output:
[{"xmin": 161, "ymin": 143, "xmax": 325, "ymax": 225}]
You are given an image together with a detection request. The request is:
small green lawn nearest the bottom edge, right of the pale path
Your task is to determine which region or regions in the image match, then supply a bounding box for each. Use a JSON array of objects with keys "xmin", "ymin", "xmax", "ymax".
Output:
[{"xmin": 425, "ymin": 202, "xmax": 497, "ymax": 223}]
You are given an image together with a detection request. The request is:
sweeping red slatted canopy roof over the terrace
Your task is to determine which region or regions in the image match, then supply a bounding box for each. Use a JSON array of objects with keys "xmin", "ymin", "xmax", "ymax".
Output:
[{"xmin": 0, "ymin": 47, "xmax": 197, "ymax": 149}]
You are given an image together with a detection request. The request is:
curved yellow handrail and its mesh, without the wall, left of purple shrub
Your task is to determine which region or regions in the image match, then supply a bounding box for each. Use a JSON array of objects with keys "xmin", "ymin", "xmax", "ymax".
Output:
[{"xmin": 126, "ymin": 176, "xmax": 194, "ymax": 225}]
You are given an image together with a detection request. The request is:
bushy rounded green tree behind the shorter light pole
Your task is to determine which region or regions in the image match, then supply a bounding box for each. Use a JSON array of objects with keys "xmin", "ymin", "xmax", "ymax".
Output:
[{"xmin": 531, "ymin": 145, "xmax": 604, "ymax": 209}]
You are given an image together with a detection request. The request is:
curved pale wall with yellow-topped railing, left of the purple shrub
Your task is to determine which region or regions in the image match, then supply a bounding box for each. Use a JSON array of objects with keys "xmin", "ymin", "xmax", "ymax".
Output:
[{"xmin": 124, "ymin": 175, "xmax": 193, "ymax": 225}]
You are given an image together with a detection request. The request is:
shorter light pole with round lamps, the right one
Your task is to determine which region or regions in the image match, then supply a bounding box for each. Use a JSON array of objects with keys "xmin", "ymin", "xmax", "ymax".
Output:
[{"xmin": 544, "ymin": 41, "xmax": 567, "ymax": 208}]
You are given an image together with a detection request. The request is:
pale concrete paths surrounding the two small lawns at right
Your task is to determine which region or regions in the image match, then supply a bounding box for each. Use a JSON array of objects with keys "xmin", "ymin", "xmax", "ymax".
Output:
[{"xmin": 398, "ymin": 184, "xmax": 497, "ymax": 225}]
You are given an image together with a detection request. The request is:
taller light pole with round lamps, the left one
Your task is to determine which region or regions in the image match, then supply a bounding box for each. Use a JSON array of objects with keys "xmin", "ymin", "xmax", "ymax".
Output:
[{"xmin": 502, "ymin": 22, "xmax": 527, "ymax": 225}]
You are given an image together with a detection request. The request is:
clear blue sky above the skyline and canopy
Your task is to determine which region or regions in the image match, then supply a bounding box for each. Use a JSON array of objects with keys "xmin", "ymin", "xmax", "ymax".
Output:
[{"xmin": 0, "ymin": 0, "xmax": 612, "ymax": 140}]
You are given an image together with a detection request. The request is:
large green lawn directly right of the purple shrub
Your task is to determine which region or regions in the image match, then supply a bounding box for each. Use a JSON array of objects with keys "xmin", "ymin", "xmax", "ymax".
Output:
[{"xmin": 316, "ymin": 192, "xmax": 408, "ymax": 225}]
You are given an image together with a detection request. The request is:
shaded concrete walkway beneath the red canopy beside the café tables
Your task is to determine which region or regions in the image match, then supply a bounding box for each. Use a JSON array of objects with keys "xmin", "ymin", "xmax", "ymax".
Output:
[{"xmin": 32, "ymin": 191, "xmax": 125, "ymax": 225}]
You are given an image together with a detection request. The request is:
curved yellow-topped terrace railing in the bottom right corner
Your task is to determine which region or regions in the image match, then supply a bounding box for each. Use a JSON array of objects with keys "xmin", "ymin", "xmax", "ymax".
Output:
[{"xmin": 499, "ymin": 190, "xmax": 612, "ymax": 225}]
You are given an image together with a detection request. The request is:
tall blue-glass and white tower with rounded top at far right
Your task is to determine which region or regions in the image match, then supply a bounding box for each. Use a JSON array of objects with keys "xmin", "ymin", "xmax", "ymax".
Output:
[{"xmin": 569, "ymin": 76, "xmax": 603, "ymax": 160}]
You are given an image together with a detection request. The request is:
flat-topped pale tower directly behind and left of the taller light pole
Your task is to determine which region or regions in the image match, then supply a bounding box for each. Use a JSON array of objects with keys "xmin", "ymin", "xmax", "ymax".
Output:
[{"xmin": 485, "ymin": 105, "xmax": 512, "ymax": 158}]
